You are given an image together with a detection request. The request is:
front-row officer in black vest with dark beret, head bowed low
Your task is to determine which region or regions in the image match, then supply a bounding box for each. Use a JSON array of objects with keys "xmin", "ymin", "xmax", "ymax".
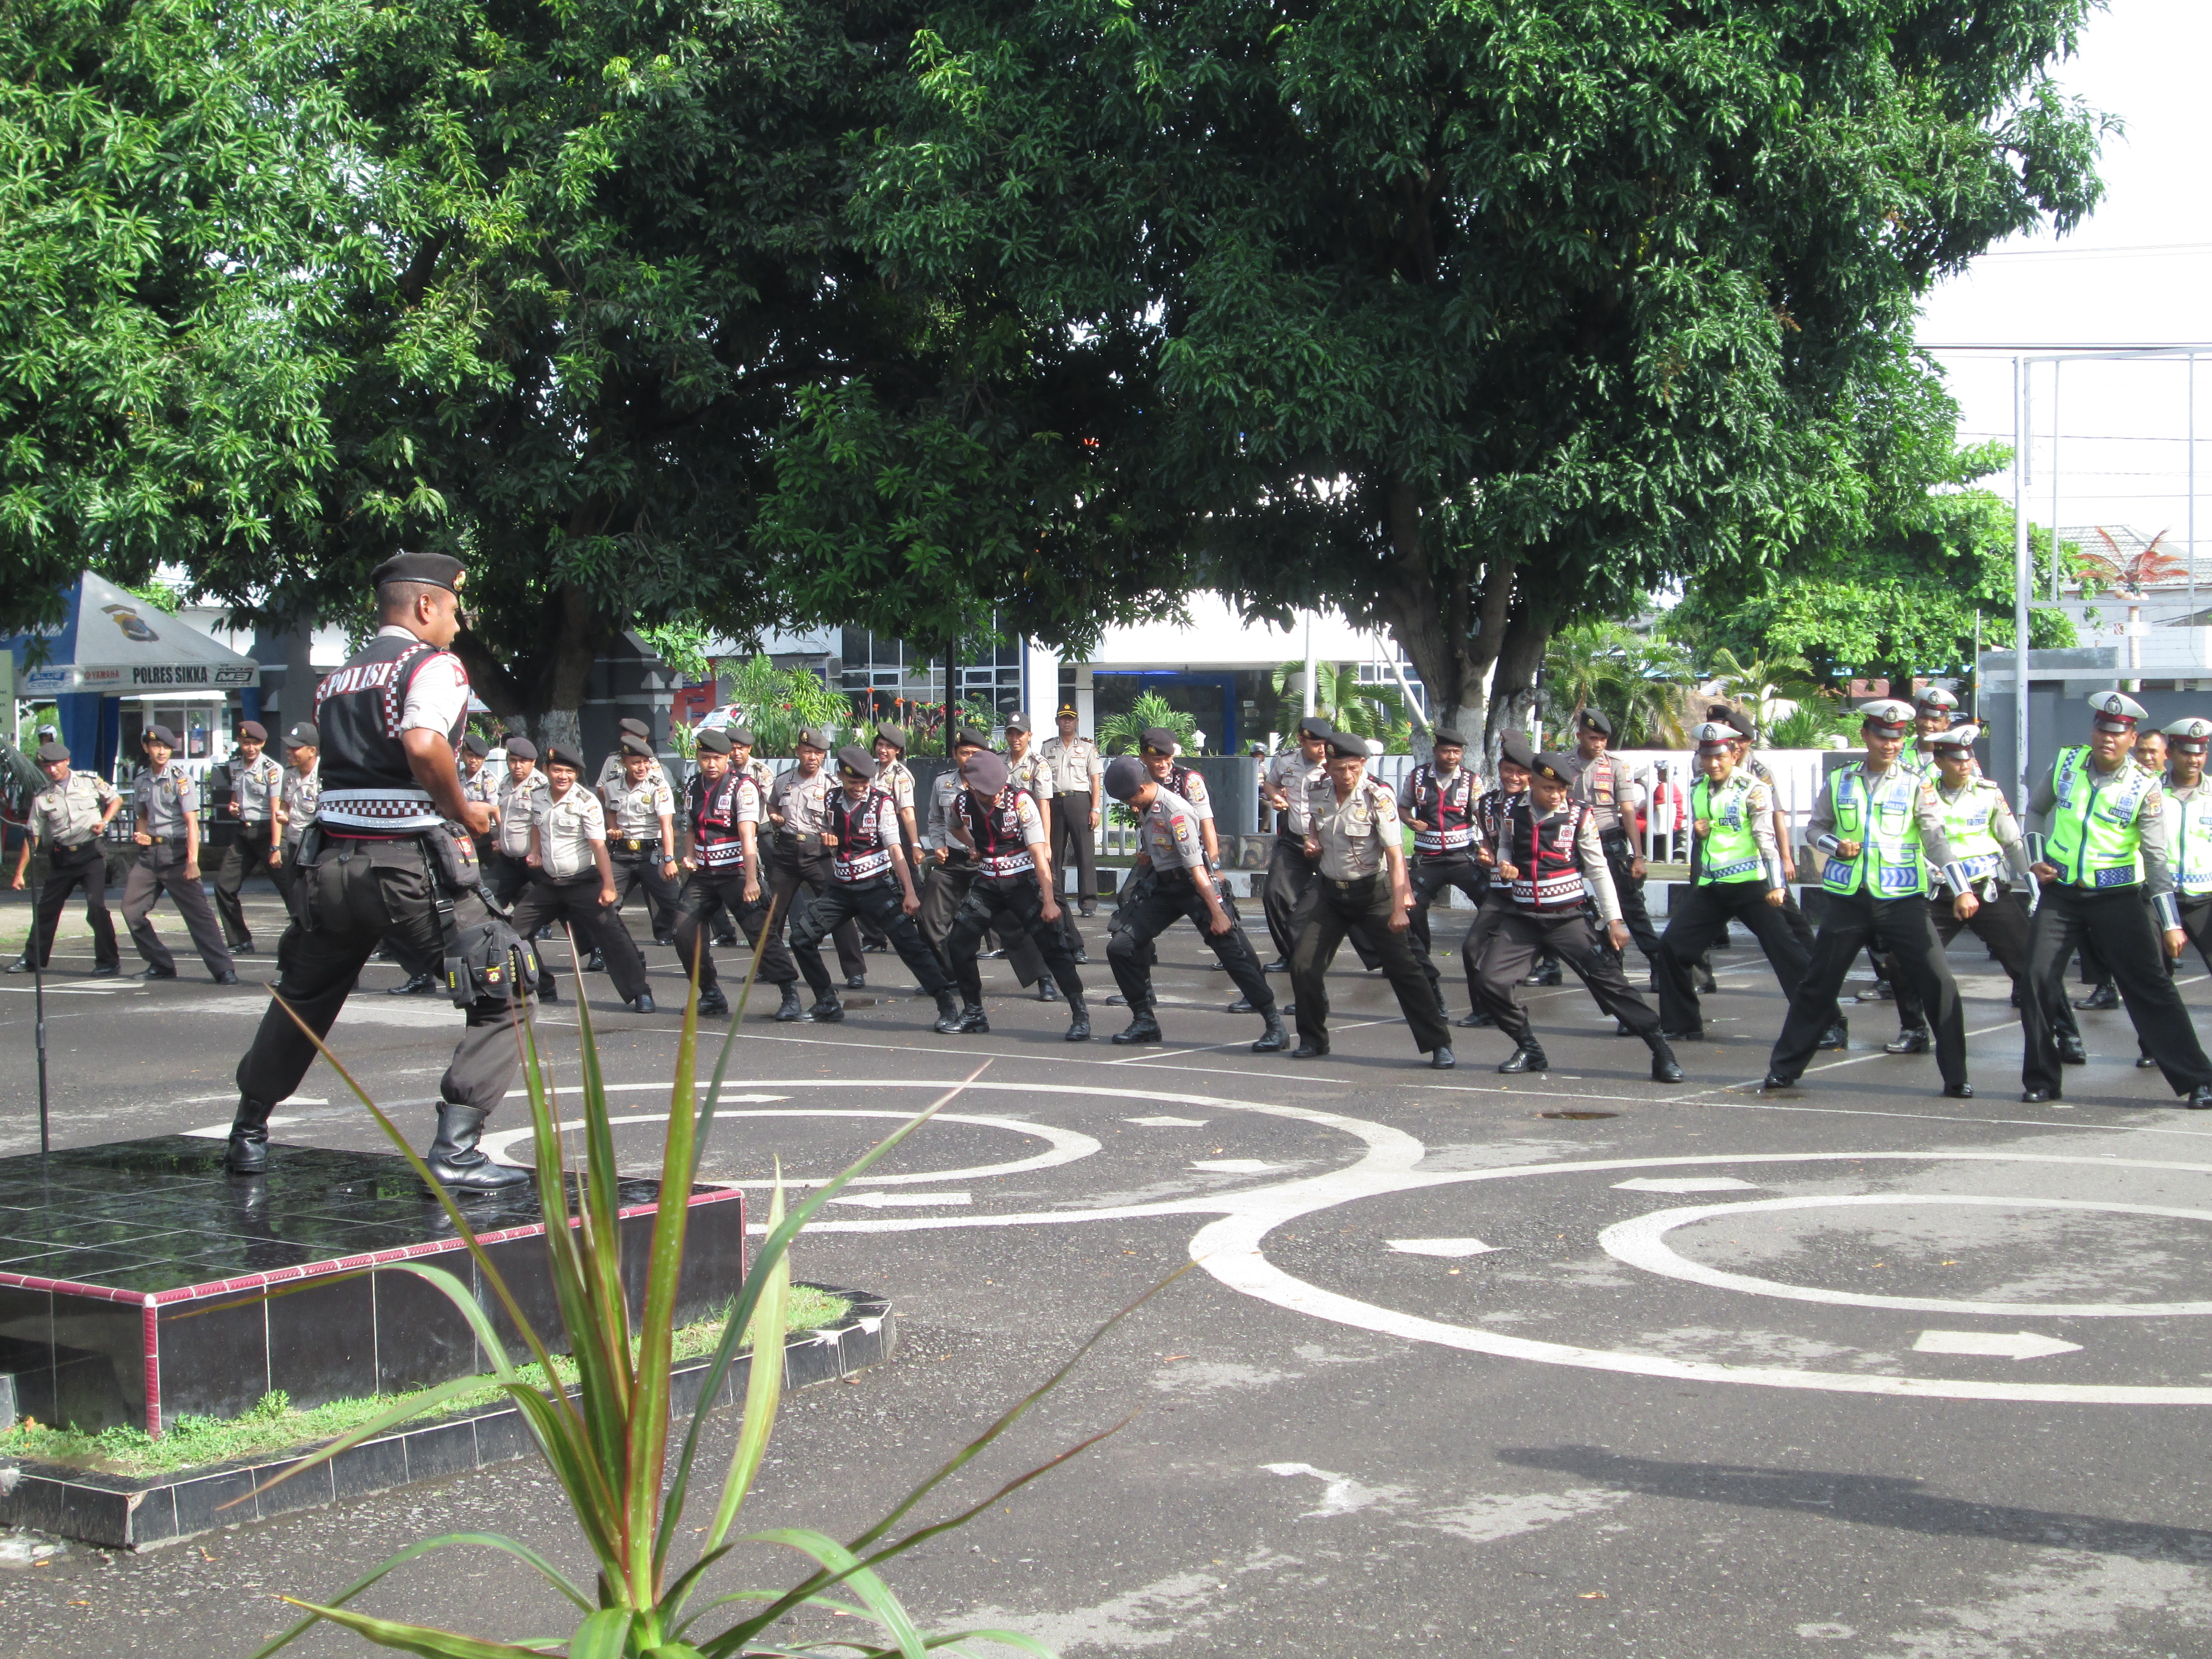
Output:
[{"xmin": 945, "ymin": 748, "xmax": 1091, "ymax": 1042}]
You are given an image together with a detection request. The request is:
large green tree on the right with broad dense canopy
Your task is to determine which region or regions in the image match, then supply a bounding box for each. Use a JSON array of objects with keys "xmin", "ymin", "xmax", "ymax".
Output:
[{"xmin": 843, "ymin": 0, "xmax": 2099, "ymax": 739}]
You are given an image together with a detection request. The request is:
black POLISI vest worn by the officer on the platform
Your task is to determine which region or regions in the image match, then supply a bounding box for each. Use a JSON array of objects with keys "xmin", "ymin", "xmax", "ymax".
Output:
[{"xmin": 314, "ymin": 635, "xmax": 469, "ymax": 836}]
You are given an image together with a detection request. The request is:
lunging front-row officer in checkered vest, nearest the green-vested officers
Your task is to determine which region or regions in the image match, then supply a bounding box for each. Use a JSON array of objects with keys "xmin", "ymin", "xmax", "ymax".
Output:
[{"xmin": 1476, "ymin": 752, "xmax": 1681, "ymax": 1084}]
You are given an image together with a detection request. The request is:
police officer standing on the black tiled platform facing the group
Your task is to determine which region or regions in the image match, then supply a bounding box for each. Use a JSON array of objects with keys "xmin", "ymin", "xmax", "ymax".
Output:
[{"xmin": 228, "ymin": 553, "xmax": 529, "ymax": 1190}]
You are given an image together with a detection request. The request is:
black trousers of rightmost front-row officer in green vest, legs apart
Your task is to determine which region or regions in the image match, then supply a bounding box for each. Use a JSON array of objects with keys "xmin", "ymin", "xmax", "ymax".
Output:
[{"xmin": 2020, "ymin": 883, "xmax": 2212, "ymax": 1095}]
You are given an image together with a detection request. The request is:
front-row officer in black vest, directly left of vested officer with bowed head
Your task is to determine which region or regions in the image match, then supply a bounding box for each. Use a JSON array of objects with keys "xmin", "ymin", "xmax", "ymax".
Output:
[{"xmin": 792, "ymin": 743, "xmax": 960, "ymax": 1033}]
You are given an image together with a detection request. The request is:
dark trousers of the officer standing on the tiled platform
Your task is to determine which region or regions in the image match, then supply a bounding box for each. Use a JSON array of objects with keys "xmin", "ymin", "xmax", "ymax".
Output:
[{"xmin": 239, "ymin": 836, "xmax": 520, "ymax": 1113}]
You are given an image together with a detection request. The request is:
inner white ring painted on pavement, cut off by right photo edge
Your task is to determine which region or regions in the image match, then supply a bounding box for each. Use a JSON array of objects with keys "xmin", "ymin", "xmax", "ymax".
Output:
[{"xmin": 1597, "ymin": 1192, "xmax": 2212, "ymax": 1318}]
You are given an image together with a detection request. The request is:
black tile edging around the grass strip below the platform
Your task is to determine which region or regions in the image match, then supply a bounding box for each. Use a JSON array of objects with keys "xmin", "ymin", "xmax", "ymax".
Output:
[{"xmin": 0, "ymin": 1285, "xmax": 898, "ymax": 1551}]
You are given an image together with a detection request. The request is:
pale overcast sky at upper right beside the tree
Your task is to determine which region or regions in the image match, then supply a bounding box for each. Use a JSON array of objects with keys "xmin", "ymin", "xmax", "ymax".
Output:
[{"xmin": 1920, "ymin": 0, "xmax": 2212, "ymax": 562}]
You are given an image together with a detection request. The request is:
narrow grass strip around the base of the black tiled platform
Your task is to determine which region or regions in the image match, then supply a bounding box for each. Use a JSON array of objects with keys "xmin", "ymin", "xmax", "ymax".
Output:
[{"xmin": 0, "ymin": 1285, "xmax": 852, "ymax": 1476}]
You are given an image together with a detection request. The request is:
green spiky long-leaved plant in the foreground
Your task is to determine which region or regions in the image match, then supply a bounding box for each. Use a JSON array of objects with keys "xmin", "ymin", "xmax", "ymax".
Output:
[{"xmin": 239, "ymin": 920, "xmax": 1153, "ymax": 1659}]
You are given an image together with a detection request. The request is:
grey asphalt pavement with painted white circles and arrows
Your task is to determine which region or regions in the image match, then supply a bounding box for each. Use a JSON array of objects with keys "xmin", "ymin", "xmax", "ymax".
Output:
[{"xmin": 0, "ymin": 896, "xmax": 2212, "ymax": 1659}]
